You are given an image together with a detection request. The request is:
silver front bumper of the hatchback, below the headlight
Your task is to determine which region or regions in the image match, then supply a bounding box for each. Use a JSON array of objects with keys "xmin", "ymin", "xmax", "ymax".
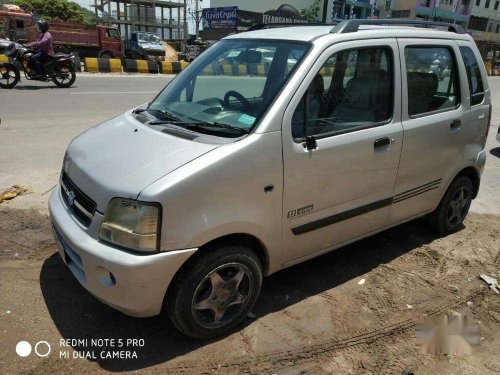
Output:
[{"xmin": 49, "ymin": 188, "xmax": 197, "ymax": 317}]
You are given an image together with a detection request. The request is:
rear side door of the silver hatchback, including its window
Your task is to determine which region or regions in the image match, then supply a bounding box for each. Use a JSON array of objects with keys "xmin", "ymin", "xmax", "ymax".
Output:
[{"xmin": 391, "ymin": 39, "xmax": 469, "ymax": 222}]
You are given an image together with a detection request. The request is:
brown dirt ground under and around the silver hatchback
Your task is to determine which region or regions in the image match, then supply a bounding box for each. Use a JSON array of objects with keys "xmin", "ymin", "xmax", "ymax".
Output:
[{"xmin": 0, "ymin": 207, "xmax": 500, "ymax": 374}]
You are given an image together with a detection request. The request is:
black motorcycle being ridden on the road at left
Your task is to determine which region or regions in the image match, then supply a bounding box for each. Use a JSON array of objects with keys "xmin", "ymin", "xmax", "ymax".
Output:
[{"xmin": 0, "ymin": 43, "xmax": 76, "ymax": 89}]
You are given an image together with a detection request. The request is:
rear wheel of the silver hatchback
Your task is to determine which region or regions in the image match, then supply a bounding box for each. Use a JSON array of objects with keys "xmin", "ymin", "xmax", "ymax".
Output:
[{"xmin": 428, "ymin": 176, "xmax": 474, "ymax": 234}]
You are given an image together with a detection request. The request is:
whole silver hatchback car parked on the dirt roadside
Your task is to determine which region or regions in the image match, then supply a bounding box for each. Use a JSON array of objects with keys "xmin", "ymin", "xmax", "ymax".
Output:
[{"xmin": 49, "ymin": 20, "xmax": 491, "ymax": 338}]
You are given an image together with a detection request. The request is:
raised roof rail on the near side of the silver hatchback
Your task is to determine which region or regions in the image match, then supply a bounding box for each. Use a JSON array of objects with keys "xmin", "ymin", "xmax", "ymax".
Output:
[{"xmin": 330, "ymin": 18, "xmax": 465, "ymax": 34}]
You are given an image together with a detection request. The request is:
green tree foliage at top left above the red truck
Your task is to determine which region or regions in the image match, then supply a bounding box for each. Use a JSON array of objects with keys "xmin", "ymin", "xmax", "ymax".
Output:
[{"xmin": 15, "ymin": 0, "xmax": 85, "ymax": 23}]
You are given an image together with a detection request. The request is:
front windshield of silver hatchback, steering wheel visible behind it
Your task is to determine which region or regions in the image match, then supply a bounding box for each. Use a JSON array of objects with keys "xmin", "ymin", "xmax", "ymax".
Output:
[{"xmin": 148, "ymin": 39, "xmax": 310, "ymax": 136}]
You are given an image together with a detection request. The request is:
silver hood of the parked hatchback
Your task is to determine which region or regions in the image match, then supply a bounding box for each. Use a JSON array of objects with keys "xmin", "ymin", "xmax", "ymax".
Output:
[{"xmin": 63, "ymin": 112, "xmax": 218, "ymax": 212}]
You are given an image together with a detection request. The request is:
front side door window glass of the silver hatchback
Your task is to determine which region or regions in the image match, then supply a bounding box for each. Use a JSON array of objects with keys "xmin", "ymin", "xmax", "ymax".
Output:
[{"xmin": 292, "ymin": 47, "xmax": 394, "ymax": 141}]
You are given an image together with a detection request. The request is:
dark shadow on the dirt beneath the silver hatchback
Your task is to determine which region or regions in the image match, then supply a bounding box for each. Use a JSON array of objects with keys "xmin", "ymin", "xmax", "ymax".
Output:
[{"xmin": 40, "ymin": 220, "xmax": 446, "ymax": 372}]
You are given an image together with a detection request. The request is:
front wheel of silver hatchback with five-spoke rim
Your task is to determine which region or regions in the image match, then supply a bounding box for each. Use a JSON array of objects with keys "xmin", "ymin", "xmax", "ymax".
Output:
[{"xmin": 166, "ymin": 244, "xmax": 262, "ymax": 339}]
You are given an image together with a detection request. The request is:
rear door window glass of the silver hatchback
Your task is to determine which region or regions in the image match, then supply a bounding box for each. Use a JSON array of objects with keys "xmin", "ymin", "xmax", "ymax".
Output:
[{"xmin": 405, "ymin": 46, "xmax": 460, "ymax": 116}]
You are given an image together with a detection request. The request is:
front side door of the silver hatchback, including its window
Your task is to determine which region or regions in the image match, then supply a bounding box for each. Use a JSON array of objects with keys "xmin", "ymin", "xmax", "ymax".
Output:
[{"xmin": 282, "ymin": 39, "xmax": 403, "ymax": 264}]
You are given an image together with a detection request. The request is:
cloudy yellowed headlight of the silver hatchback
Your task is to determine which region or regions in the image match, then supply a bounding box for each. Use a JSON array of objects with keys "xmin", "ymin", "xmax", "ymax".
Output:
[{"xmin": 99, "ymin": 198, "xmax": 161, "ymax": 253}]
